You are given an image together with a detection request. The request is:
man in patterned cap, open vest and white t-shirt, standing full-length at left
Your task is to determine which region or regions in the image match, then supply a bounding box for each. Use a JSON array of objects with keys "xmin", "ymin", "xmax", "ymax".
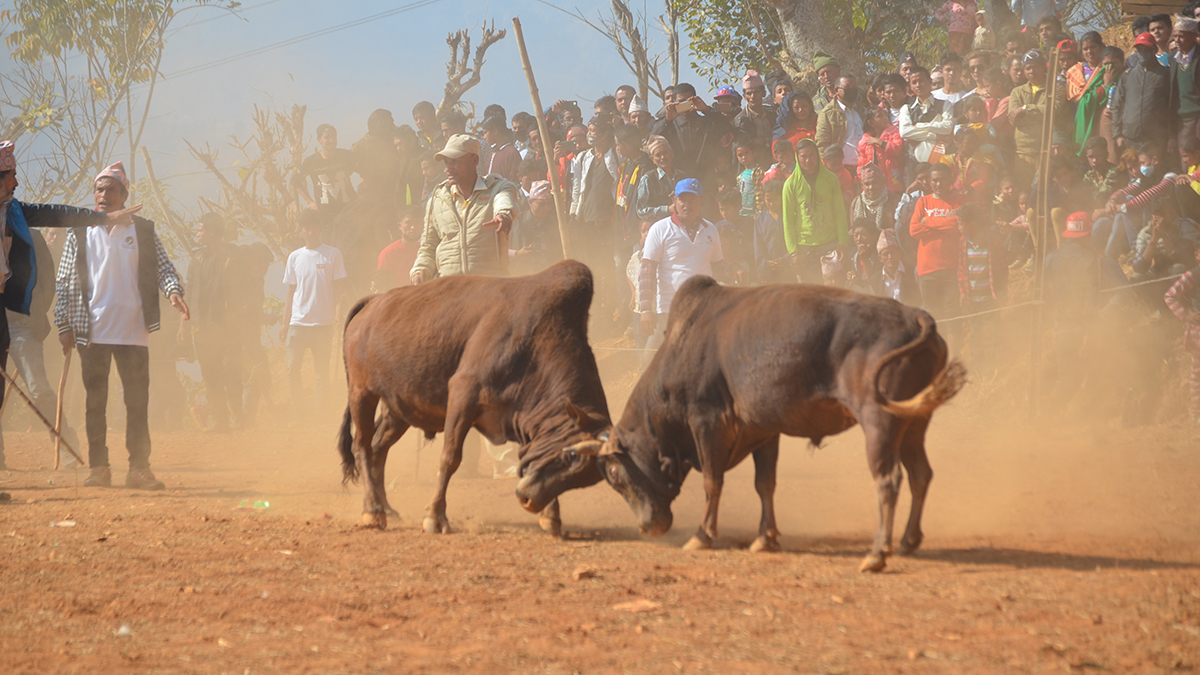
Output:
[{"xmin": 54, "ymin": 162, "xmax": 189, "ymax": 490}]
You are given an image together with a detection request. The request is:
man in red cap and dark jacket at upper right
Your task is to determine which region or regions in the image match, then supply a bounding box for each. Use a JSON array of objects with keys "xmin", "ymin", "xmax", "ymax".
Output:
[{"xmin": 1112, "ymin": 32, "xmax": 1177, "ymax": 151}]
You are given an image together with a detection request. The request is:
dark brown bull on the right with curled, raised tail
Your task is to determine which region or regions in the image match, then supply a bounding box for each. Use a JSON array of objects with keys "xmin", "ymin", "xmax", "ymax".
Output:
[{"xmin": 568, "ymin": 276, "xmax": 966, "ymax": 572}]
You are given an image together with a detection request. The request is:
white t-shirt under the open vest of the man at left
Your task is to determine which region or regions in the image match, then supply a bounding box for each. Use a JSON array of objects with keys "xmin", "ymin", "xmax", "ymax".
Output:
[{"xmin": 88, "ymin": 223, "xmax": 150, "ymax": 347}]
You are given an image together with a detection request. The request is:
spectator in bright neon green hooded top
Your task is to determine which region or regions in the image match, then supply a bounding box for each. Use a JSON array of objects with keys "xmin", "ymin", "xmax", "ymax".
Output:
[{"xmin": 784, "ymin": 139, "xmax": 850, "ymax": 283}]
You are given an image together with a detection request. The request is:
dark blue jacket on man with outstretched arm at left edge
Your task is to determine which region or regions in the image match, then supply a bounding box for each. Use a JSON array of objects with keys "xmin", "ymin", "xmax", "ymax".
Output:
[{"xmin": 4, "ymin": 199, "xmax": 106, "ymax": 315}]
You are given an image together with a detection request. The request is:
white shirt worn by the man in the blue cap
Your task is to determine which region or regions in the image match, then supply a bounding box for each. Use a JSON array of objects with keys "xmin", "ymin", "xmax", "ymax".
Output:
[{"xmin": 642, "ymin": 216, "xmax": 725, "ymax": 315}]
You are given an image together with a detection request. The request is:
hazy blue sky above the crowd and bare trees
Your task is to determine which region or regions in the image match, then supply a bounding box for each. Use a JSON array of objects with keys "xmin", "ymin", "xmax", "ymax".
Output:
[{"xmin": 0, "ymin": 0, "xmax": 706, "ymax": 213}]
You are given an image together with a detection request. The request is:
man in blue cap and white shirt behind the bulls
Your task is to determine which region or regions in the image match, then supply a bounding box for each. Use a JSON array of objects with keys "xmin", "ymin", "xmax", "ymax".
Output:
[{"xmin": 637, "ymin": 178, "xmax": 725, "ymax": 350}]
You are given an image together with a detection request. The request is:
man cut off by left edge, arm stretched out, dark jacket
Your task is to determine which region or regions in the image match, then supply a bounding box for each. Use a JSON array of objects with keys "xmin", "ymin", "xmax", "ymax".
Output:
[{"xmin": 0, "ymin": 141, "xmax": 142, "ymax": 470}]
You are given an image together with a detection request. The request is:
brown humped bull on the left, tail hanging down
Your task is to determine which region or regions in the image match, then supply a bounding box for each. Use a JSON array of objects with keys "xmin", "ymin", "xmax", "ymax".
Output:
[{"xmin": 338, "ymin": 261, "xmax": 611, "ymax": 533}]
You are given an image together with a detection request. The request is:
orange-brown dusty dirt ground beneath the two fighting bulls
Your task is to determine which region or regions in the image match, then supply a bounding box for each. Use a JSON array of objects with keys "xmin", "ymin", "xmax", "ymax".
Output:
[{"xmin": 0, "ymin": 362, "xmax": 1200, "ymax": 674}]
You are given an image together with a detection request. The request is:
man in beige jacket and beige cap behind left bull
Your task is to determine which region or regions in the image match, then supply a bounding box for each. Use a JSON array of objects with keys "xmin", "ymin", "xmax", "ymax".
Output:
[{"xmin": 409, "ymin": 133, "xmax": 516, "ymax": 285}]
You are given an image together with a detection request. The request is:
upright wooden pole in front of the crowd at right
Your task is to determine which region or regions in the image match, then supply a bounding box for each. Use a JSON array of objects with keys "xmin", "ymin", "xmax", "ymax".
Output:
[{"xmin": 1030, "ymin": 47, "xmax": 1058, "ymax": 419}]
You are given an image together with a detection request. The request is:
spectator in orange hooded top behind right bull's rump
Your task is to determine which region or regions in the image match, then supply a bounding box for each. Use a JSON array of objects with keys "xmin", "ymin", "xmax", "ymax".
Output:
[{"xmin": 908, "ymin": 163, "xmax": 961, "ymax": 318}]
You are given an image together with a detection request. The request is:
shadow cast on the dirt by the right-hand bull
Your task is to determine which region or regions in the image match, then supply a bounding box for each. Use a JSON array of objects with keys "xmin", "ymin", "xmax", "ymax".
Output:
[{"xmin": 768, "ymin": 533, "xmax": 1200, "ymax": 572}]
